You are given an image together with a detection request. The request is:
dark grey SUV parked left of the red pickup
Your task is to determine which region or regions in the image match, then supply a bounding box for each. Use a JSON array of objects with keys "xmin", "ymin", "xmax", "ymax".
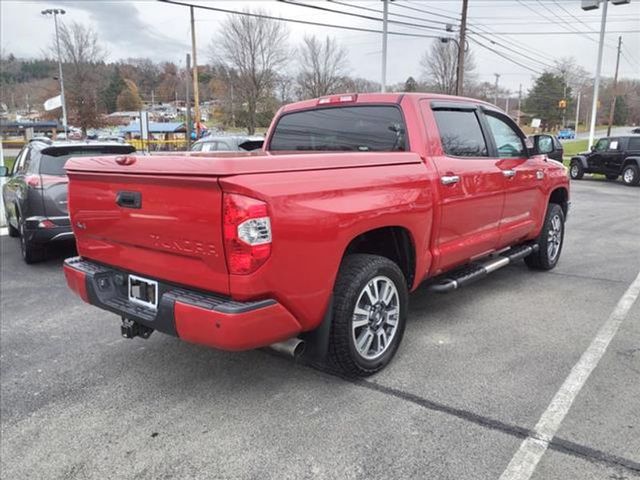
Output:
[{"xmin": 0, "ymin": 138, "xmax": 135, "ymax": 263}]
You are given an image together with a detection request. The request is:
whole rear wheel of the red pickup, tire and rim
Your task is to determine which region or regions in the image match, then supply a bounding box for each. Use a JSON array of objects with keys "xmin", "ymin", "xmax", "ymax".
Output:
[{"xmin": 329, "ymin": 254, "xmax": 409, "ymax": 376}]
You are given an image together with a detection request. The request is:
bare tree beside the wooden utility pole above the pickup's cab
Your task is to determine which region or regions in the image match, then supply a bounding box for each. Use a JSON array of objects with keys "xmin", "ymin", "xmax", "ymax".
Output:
[{"xmin": 420, "ymin": 40, "xmax": 476, "ymax": 95}]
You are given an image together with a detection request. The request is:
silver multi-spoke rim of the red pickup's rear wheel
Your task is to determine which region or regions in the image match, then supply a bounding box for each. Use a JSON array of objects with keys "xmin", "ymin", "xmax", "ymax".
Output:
[{"xmin": 351, "ymin": 276, "xmax": 400, "ymax": 360}]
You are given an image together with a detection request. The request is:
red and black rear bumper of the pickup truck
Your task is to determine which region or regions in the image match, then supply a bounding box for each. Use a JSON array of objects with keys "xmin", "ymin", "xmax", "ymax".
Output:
[{"xmin": 64, "ymin": 257, "xmax": 302, "ymax": 350}]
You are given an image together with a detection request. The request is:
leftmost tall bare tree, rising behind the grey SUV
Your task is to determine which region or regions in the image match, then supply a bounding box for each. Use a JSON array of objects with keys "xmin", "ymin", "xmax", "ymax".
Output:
[{"xmin": 52, "ymin": 22, "xmax": 106, "ymax": 134}]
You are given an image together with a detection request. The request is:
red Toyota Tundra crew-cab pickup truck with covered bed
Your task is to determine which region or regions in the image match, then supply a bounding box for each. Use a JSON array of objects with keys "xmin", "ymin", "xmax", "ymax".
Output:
[{"xmin": 64, "ymin": 93, "xmax": 569, "ymax": 375}]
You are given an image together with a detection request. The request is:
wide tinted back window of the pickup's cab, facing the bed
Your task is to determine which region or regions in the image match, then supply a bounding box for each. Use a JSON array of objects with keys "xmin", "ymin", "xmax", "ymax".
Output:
[{"xmin": 269, "ymin": 105, "xmax": 407, "ymax": 152}]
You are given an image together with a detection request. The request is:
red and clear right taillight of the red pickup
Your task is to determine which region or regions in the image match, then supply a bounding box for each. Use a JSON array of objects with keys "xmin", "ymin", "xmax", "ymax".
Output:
[{"xmin": 222, "ymin": 193, "xmax": 271, "ymax": 275}]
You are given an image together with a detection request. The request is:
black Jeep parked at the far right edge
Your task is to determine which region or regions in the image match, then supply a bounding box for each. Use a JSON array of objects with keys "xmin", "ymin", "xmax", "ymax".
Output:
[{"xmin": 569, "ymin": 137, "xmax": 640, "ymax": 185}]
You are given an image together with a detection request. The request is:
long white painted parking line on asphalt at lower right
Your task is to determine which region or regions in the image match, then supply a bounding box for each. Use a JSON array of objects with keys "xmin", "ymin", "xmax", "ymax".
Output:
[{"xmin": 500, "ymin": 273, "xmax": 640, "ymax": 480}]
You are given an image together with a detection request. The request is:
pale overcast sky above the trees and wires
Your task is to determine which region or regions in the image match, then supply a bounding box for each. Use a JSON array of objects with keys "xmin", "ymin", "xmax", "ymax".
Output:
[{"xmin": 0, "ymin": 0, "xmax": 640, "ymax": 92}]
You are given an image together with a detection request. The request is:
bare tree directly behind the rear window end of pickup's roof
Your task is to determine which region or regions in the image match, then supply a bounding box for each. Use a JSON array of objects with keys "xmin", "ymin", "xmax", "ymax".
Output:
[{"xmin": 297, "ymin": 35, "xmax": 347, "ymax": 98}]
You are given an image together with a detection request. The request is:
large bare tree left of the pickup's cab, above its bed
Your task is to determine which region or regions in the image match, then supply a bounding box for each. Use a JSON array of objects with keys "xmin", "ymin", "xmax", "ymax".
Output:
[{"xmin": 212, "ymin": 11, "xmax": 289, "ymax": 134}]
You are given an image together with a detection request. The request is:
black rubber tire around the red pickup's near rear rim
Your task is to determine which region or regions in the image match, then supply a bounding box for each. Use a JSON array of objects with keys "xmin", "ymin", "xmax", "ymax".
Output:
[{"xmin": 329, "ymin": 254, "xmax": 409, "ymax": 377}]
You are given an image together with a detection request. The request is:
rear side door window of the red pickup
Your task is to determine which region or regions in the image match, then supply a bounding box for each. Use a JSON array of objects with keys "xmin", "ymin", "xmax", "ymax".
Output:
[{"xmin": 433, "ymin": 110, "xmax": 489, "ymax": 157}]
